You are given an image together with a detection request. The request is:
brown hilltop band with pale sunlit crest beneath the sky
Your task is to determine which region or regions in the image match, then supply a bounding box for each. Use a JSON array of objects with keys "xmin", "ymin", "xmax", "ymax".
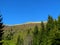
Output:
[{"xmin": 4, "ymin": 22, "xmax": 46, "ymax": 30}]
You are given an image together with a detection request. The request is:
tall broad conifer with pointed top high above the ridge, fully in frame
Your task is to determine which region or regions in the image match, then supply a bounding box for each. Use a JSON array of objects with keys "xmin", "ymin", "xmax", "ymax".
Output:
[{"xmin": 46, "ymin": 16, "xmax": 54, "ymax": 45}]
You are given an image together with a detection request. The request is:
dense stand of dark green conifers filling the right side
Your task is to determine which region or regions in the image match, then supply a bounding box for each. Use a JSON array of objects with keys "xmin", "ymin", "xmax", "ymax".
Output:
[{"xmin": 32, "ymin": 16, "xmax": 60, "ymax": 45}]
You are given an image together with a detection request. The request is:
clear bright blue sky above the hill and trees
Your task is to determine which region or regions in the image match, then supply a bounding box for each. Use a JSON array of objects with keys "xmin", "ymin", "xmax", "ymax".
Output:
[{"xmin": 0, "ymin": 0, "xmax": 60, "ymax": 25}]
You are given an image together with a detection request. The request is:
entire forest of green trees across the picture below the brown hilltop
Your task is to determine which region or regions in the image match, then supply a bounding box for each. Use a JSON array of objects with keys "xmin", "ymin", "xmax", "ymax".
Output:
[{"xmin": 0, "ymin": 15, "xmax": 60, "ymax": 45}]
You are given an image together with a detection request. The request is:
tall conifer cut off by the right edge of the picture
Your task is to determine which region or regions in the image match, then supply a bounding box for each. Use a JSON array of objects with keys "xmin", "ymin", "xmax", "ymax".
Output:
[{"xmin": 52, "ymin": 16, "xmax": 60, "ymax": 45}]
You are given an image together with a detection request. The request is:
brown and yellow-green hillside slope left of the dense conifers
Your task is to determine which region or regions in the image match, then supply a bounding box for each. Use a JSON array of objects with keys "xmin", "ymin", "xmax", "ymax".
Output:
[{"xmin": 3, "ymin": 23, "xmax": 41, "ymax": 45}]
